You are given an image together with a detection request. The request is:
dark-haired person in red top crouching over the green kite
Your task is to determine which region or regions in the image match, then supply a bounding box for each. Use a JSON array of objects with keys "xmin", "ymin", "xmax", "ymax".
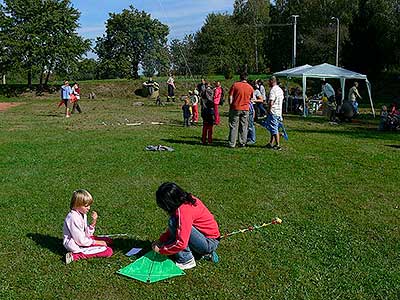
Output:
[{"xmin": 152, "ymin": 182, "xmax": 220, "ymax": 270}]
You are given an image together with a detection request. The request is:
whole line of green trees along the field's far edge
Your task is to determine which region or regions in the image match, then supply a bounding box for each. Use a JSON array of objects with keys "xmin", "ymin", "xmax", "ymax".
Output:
[{"xmin": 0, "ymin": 0, "xmax": 400, "ymax": 85}]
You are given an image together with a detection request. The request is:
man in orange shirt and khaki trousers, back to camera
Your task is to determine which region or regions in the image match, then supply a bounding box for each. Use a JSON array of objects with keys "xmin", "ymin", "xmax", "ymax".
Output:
[{"xmin": 229, "ymin": 73, "xmax": 254, "ymax": 148}]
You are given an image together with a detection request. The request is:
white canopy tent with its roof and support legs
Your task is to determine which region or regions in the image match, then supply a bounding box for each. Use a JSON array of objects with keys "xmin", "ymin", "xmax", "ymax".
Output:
[{"xmin": 274, "ymin": 63, "xmax": 375, "ymax": 117}]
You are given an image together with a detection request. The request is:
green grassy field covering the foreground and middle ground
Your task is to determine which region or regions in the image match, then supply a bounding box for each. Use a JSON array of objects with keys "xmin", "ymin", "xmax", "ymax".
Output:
[{"xmin": 0, "ymin": 92, "xmax": 400, "ymax": 299}]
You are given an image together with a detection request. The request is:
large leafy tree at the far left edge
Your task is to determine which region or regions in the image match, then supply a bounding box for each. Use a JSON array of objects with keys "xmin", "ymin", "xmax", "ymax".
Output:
[{"xmin": 0, "ymin": 0, "xmax": 90, "ymax": 86}]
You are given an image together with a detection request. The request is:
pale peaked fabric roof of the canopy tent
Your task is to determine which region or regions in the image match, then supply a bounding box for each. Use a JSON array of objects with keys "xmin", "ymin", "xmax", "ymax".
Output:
[{"xmin": 274, "ymin": 63, "xmax": 367, "ymax": 80}]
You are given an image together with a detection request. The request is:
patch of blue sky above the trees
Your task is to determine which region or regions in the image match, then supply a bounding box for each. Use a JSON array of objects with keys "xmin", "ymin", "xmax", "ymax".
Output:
[{"xmin": 71, "ymin": 0, "xmax": 234, "ymax": 39}]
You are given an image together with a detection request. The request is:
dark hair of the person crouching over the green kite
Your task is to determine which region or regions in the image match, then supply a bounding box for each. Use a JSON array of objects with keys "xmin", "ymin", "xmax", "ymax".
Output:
[{"xmin": 156, "ymin": 182, "xmax": 196, "ymax": 214}]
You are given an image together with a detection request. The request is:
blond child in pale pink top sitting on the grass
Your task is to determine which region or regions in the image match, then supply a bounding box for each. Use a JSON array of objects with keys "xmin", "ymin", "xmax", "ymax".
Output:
[{"xmin": 63, "ymin": 190, "xmax": 113, "ymax": 264}]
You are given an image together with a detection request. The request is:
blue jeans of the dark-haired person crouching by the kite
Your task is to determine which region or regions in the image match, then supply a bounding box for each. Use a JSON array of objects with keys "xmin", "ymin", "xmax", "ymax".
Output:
[{"xmin": 167, "ymin": 217, "xmax": 219, "ymax": 263}]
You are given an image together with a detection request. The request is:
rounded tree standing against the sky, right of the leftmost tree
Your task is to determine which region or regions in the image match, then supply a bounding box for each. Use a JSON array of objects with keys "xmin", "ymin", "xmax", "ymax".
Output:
[{"xmin": 95, "ymin": 5, "xmax": 169, "ymax": 78}]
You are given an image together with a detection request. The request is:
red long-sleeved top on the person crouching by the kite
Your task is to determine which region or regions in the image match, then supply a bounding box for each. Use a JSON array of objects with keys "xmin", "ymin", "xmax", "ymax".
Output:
[{"xmin": 159, "ymin": 197, "xmax": 220, "ymax": 255}]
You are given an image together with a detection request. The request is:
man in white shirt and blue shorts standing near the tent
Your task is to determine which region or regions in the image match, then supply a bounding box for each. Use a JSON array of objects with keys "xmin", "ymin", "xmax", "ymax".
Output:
[{"xmin": 266, "ymin": 76, "xmax": 284, "ymax": 150}]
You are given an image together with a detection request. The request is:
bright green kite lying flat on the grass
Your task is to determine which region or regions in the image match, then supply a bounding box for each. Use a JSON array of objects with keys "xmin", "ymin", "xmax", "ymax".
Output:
[{"xmin": 117, "ymin": 251, "xmax": 185, "ymax": 283}]
